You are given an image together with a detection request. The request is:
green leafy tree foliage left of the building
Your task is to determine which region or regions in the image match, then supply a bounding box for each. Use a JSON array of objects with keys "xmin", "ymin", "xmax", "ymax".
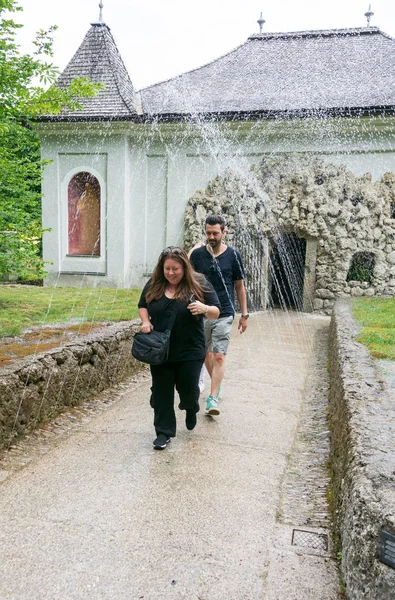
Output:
[{"xmin": 0, "ymin": 0, "xmax": 103, "ymax": 278}]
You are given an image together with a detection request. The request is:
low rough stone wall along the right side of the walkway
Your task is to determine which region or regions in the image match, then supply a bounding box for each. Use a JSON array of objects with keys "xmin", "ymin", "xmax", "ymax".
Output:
[{"xmin": 329, "ymin": 301, "xmax": 395, "ymax": 600}]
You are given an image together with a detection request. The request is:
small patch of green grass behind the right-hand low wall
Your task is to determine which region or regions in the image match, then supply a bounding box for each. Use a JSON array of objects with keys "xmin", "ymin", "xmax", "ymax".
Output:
[{"xmin": 352, "ymin": 298, "xmax": 395, "ymax": 360}]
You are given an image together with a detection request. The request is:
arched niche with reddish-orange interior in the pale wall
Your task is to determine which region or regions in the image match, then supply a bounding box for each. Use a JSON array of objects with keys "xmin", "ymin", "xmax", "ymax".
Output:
[{"xmin": 67, "ymin": 172, "xmax": 100, "ymax": 256}]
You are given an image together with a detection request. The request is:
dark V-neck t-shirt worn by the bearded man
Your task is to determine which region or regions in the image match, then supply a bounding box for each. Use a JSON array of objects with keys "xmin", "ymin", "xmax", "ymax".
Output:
[{"xmin": 190, "ymin": 246, "xmax": 245, "ymax": 317}]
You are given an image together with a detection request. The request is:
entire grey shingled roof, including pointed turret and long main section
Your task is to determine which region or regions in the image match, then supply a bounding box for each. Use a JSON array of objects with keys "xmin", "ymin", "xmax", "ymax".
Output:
[{"xmin": 45, "ymin": 22, "xmax": 395, "ymax": 121}]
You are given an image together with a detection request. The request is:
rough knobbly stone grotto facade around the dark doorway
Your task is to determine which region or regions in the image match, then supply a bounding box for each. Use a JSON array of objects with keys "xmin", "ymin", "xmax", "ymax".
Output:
[{"xmin": 185, "ymin": 154, "xmax": 395, "ymax": 314}]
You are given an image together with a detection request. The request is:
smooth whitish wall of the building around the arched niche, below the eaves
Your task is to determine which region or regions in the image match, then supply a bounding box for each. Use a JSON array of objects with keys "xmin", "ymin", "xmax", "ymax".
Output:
[{"xmin": 38, "ymin": 118, "xmax": 395, "ymax": 287}]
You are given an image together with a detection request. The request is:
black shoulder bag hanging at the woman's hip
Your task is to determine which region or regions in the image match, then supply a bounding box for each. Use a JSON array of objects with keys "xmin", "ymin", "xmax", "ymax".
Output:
[{"xmin": 132, "ymin": 306, "xmax": 176, "ymax": 365}]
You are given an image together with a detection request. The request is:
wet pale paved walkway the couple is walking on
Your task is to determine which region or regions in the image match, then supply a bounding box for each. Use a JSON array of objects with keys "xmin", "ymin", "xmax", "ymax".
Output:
[{"xmin": 0, "ymin": 312, "xmax": 339, "ymax": 600}]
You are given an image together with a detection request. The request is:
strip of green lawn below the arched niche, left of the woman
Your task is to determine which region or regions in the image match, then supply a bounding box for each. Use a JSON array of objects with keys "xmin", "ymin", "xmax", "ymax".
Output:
[{"xmin": 0, "ymin": 285, "xmax": 140, "ymax": 337}]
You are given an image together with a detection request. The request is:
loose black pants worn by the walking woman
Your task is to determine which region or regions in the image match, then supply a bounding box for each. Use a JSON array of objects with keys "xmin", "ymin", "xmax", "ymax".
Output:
[{"xmin": 151, "ymin": 360, "xmax": 203, "ymax": 437}]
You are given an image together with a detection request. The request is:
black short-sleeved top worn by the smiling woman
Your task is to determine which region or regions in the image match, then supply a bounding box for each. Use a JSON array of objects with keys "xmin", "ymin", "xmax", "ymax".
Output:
[{"xmin": 138, "ymin": 276, "xmax": 221, "ymax": 362}]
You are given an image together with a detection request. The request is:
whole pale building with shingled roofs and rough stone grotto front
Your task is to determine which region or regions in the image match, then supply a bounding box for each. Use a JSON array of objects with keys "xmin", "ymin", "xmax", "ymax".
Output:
[{"xmin": 37, "ymin": 8, "xmax": 395, "ymax": 310}]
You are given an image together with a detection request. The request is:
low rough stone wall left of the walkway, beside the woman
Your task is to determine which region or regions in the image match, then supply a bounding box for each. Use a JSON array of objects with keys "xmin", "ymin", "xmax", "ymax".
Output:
[{"xmin": 0, "ymin": 321, "xmax": 142, "ymax": 448}]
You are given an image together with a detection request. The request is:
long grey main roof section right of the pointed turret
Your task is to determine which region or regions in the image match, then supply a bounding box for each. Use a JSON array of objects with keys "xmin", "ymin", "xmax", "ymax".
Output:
[{"xmin": 140, "ymin": 27, "xmax": 395, "ymax": 115}]
